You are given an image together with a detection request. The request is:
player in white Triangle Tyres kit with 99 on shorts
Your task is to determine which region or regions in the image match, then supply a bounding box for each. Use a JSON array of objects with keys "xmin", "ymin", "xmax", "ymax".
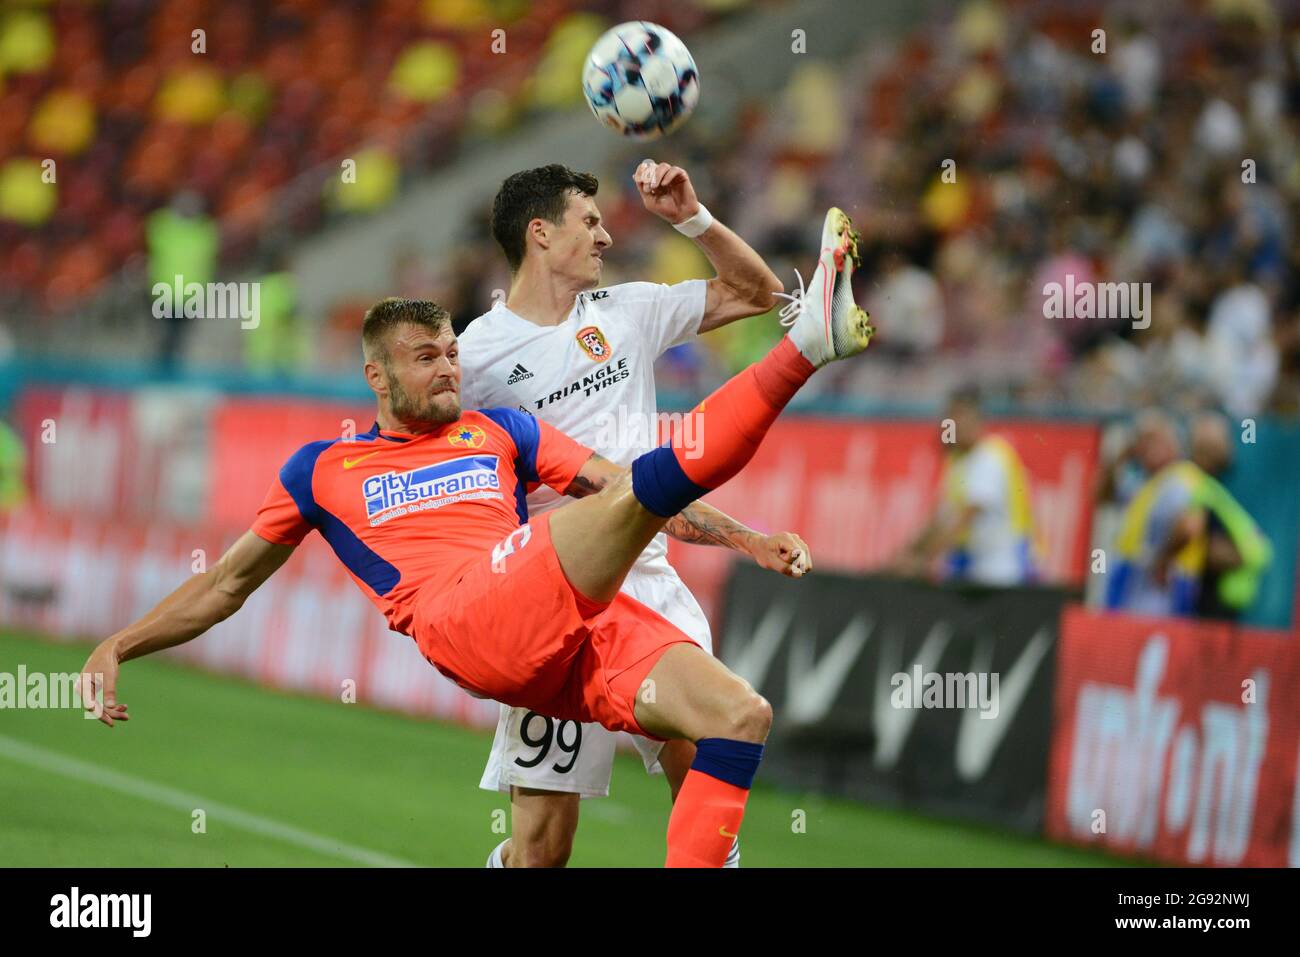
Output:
[{"xmin": 460, "ymin": 160, "xmax": 811, "ymax": 867}]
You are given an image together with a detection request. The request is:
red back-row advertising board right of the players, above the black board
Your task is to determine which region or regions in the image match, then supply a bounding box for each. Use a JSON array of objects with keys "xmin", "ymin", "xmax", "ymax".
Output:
[{"xmin": 670, "ymin": 419, "xmax": 1099, "ymax": 623}]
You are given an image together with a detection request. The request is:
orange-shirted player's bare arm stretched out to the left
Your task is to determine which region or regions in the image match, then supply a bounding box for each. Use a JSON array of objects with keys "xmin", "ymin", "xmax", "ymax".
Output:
[{"xmin": 81, "ymin": 532, "xmax": 294, "ymax": 727}]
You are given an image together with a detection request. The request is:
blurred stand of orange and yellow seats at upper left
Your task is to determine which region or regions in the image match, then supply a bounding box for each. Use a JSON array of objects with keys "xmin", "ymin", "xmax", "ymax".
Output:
[{"xmin": 0, "ymin": 0, "xmax": 709, "ymax": 321}]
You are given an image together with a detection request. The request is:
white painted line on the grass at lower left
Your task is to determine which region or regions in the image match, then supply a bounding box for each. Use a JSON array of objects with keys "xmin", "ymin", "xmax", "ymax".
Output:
[{"xmin": 0, "ymin": 735, "xmax": 419, "ymax": 867}]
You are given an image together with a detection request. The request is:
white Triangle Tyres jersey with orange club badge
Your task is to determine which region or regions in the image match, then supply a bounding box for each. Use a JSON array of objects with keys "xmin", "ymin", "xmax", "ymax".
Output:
[{"xmin": 460, "ymin": 280, "xmax": 707, "ymax": 566}]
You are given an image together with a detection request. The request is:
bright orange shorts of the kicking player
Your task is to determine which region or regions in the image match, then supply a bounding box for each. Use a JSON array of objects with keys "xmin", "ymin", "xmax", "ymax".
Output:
[{"xmin": 411, "ymin": 512, "xmax": 696, "ymax": 735}]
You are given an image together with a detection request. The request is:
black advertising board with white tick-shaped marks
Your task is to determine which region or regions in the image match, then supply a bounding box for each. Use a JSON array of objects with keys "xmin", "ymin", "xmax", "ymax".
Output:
[{"xmin": 723, "ymin": 566, "xmax": 1070, "ymax": 833}]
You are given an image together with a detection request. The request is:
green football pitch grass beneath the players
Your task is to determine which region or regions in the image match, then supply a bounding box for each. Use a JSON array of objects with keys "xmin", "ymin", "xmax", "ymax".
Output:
[{"xmin": 0, "ymin": 632, "xmax": 1121, "ymax": 867}]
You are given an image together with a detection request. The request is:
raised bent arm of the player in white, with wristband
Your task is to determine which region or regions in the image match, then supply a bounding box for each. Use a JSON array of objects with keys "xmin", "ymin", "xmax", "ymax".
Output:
[{"xmin": 632, "ymin": 160, "xmax": 785, "ymax": 333}]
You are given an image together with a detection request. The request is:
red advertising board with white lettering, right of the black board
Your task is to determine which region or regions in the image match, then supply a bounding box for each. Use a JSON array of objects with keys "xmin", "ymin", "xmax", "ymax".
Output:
[{"xmin": 1047, "ymin": 607, "xmax": 1300, "ymax": 867}]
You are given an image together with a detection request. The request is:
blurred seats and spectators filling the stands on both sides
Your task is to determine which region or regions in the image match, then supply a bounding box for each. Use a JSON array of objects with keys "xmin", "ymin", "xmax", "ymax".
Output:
[{"xmin": 0, "ymin": 0, "xmax": 1300, "ymax": 416}]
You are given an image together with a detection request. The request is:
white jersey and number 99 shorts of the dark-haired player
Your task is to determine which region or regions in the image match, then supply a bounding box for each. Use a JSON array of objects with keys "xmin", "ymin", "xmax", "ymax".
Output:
[{"xmin": 460, "ymin": 280, "xmax": 712, "ymax": 797}]
